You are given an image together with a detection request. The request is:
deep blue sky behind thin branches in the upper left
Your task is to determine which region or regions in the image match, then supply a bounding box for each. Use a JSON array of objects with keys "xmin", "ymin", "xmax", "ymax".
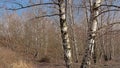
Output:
[{"xmin": 0, "ymin": 0, "xmax": 49, "ymax": 16}]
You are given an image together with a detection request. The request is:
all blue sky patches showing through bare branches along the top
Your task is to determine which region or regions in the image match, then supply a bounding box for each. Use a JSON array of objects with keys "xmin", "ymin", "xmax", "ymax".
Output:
[{"xmin": 0, "ymin": 0, "xmax": 120, "ymax": 23}]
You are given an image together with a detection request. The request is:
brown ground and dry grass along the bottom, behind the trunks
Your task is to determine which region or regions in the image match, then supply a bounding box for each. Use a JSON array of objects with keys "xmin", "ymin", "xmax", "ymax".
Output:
[{"xmin": 0, "ymin": 48, "xmax": 120, "ymax": 68}]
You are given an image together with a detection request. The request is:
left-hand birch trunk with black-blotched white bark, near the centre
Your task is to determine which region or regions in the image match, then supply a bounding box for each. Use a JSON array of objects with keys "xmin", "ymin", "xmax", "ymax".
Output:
[{"xmin": 58, "ymin": 0, "xmax": 72, "ymax": 68}]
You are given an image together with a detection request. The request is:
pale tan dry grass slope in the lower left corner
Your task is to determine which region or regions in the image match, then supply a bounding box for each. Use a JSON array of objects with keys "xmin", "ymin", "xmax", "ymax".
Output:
[{"xmin": 0, "ymin": 47, "xmax": 35, "ymax": 68}]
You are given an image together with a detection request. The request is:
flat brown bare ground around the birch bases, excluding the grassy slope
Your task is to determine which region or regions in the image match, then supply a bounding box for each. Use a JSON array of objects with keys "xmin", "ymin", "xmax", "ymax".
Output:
[{"xmin": 37, "ymin": 58, "xmax": 120, "ymax": 68}]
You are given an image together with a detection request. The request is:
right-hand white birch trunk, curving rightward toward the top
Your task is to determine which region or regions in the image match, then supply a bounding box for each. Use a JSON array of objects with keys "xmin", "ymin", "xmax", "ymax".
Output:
[{"xmin": 81, "ymin": 0, "xmax": 101, "ymax": 68}]
